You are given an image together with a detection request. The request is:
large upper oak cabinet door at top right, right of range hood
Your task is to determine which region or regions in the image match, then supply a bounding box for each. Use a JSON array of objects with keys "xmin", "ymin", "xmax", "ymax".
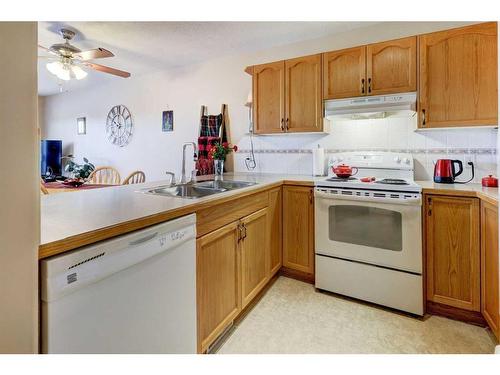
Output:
[{"xmin": 419, "ymin": 22, "xmax": 498, "ymax": 128}]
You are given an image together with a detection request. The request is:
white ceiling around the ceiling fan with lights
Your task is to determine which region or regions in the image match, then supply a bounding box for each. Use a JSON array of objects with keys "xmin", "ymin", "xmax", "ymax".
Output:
[{"xmin": 38, "ymin": 22, "xmax": 374, "ymax": 96}]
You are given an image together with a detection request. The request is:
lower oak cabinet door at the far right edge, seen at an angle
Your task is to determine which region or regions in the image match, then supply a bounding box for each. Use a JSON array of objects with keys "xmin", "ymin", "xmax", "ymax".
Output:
[{"xmin": 481, "ymin": 201, "xmax": 500, "ymax": 339}]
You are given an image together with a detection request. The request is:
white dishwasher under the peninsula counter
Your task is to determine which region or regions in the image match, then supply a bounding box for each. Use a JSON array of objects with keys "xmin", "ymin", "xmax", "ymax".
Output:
[{"xmin": 41, "ymin": 215, "xmax": 196, "ymax": 353}]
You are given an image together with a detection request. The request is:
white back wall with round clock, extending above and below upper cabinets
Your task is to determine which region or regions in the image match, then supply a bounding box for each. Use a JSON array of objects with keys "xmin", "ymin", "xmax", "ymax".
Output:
[{"xmin": 42, "ymin": 22, "xmax": 492, "ymax": 180}]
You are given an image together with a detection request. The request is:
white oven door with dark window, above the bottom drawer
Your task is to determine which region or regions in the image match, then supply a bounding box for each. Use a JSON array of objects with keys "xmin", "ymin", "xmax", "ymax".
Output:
[{"xmin": 315, "ymin": 189, "xmax": 422, "ymax": 274}]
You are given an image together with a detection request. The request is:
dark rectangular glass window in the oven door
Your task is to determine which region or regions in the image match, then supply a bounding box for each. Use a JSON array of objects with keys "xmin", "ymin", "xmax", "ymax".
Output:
[{"xmin": 328, "ymin": 205, "xmax": 403, "ymax": 251}]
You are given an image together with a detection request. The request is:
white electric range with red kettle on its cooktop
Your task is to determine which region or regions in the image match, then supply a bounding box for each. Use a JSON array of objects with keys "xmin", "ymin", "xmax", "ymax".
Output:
[{"xmin": 315, "ymin": 152, "xmax": 423, "ymax": 315}]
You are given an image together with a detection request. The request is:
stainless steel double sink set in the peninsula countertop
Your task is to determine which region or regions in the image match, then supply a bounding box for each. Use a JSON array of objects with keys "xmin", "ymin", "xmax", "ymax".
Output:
[{"xmin": 144, "ymin": 180, "xmax": 256, "ymax": 199}]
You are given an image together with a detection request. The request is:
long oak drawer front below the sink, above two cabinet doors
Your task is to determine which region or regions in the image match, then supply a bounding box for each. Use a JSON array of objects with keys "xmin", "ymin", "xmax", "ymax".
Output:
[{"xmin": 196, "ymin": 191, "xmax": 269, "ymax": 237}]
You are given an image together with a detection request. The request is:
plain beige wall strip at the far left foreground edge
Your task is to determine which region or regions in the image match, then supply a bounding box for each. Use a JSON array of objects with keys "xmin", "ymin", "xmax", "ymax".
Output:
[{"xmin": 0, "ymin": 22, "xmax": 40, "ymax": 353}]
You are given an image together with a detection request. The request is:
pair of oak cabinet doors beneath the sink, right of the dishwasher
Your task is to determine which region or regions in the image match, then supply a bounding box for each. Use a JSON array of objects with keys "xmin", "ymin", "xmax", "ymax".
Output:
[{"xmin": 196, "ymin": 207, "xmax": 271, "ymax": 353}]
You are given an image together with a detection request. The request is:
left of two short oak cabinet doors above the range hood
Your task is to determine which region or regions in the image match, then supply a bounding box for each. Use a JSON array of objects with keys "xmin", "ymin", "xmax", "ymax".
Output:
[{"xmin": 323, "ymin": 46, "xmax": 367, "ymax": 99}]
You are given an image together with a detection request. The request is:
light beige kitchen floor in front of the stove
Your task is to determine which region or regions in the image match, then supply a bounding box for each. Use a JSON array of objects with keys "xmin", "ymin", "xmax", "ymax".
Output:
[{"xmin": 218, "ymin": 277, "xmax": 495, "ymax": 354}]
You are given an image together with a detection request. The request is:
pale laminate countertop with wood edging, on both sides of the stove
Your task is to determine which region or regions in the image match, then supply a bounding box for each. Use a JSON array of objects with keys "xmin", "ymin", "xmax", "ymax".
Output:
[{"xmin": 39, "ymin": 173, "xmax": 498, "ymax": 258}]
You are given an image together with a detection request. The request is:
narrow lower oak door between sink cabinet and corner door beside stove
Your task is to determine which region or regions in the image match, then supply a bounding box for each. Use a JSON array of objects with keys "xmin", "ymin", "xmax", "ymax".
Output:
[{"xmin": 269, "ymin": 188, "xmax": 283, "ymax": 277}]
